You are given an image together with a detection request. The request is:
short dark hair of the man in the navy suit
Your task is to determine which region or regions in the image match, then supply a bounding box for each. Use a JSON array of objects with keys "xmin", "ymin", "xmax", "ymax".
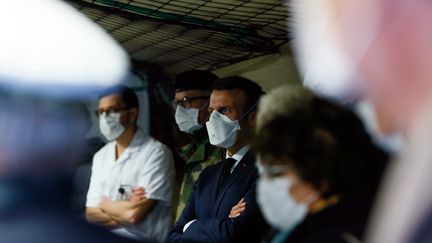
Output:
[{"xmin": 213, "ymin": 76, "xmax": 264, "ymax": 112}]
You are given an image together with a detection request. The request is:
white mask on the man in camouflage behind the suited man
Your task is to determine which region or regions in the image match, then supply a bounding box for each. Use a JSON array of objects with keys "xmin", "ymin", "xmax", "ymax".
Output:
[{"xmin": 175, "ymin": 105, "xmax": 203, "ymax": 134}]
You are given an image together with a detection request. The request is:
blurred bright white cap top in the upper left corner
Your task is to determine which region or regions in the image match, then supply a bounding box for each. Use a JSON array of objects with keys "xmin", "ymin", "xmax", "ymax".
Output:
[{"xmin": 0, "ymin": 0, "xmax": 129, "ymax": 93}]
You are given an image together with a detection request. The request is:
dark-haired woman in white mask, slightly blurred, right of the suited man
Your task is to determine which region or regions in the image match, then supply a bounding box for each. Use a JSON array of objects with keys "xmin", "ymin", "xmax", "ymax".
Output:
[{"xmin": 251, "ymin": 86, "xmax": 387, "ymax": 243}]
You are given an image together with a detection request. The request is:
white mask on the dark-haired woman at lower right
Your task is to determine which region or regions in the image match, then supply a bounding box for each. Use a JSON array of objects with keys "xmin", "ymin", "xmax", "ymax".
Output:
[{"xmin": 257, "ymin": 176, "xmax": 316, "ymax": 230}]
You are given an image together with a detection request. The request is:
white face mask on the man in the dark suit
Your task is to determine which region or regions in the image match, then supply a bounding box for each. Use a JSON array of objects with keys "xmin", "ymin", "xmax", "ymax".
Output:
[{"xmin": 206, "ymin": 111, "xmax": 240, "ymax": 148}]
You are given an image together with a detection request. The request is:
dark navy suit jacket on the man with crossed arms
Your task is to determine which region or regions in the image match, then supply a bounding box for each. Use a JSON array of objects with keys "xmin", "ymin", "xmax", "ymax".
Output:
[{"xmin": 169, "ymin": 152, "xmax": 267, "ymax": 242}]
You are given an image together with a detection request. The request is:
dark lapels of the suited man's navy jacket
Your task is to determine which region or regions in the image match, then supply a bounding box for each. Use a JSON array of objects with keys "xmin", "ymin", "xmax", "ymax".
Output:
[{"xmin": 214, "ymin": 152, "xmax": 254, "ymax": 215}]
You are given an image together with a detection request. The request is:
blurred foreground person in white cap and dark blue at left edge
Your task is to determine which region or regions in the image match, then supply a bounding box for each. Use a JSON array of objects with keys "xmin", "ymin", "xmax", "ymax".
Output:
[{"xmin": 0, "ymin": 0, "xmax": 138, "ymax": 243}]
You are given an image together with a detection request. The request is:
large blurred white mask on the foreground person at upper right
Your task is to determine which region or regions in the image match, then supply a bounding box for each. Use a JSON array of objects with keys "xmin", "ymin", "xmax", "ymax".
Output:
[{"xmin": 290, "ymin": 0, "xmax": 378, "ymax": 99}]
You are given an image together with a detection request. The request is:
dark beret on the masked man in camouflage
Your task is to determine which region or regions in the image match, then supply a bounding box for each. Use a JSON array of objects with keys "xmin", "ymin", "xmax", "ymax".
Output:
[{"xmin": 174, "ymin": 70, "xmax": 218, "ymax": 92}]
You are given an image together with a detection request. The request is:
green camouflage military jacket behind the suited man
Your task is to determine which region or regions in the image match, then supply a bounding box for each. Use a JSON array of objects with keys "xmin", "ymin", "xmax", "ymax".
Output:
[{"xmin": 176, "ymin": 138, "xmax": 225, "ymax": 221}]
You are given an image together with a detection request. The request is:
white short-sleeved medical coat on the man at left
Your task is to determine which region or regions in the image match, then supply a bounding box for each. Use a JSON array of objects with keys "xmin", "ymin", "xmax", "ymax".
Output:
[{"xmin": 86, "ymin": 129, "xmax": 175, "ymax": 241}]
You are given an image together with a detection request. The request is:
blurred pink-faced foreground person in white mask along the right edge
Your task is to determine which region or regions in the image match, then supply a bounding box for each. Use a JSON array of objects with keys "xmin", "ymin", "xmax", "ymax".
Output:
[{"xmin": 292, "ymin": 0, "xmax": 432, "ymax": 243}]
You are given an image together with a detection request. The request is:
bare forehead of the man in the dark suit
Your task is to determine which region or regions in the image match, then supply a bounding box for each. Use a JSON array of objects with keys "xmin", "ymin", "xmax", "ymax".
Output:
[{"xmin": 210, "ymin": 89, "xmax": 246, "ymax": 107}]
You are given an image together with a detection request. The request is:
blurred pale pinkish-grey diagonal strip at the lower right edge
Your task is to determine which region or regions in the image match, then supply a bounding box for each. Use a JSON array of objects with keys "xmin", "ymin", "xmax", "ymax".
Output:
[{"xmin": 366, "ymin": 98, "xmax": 432, "ymax": 243}]
